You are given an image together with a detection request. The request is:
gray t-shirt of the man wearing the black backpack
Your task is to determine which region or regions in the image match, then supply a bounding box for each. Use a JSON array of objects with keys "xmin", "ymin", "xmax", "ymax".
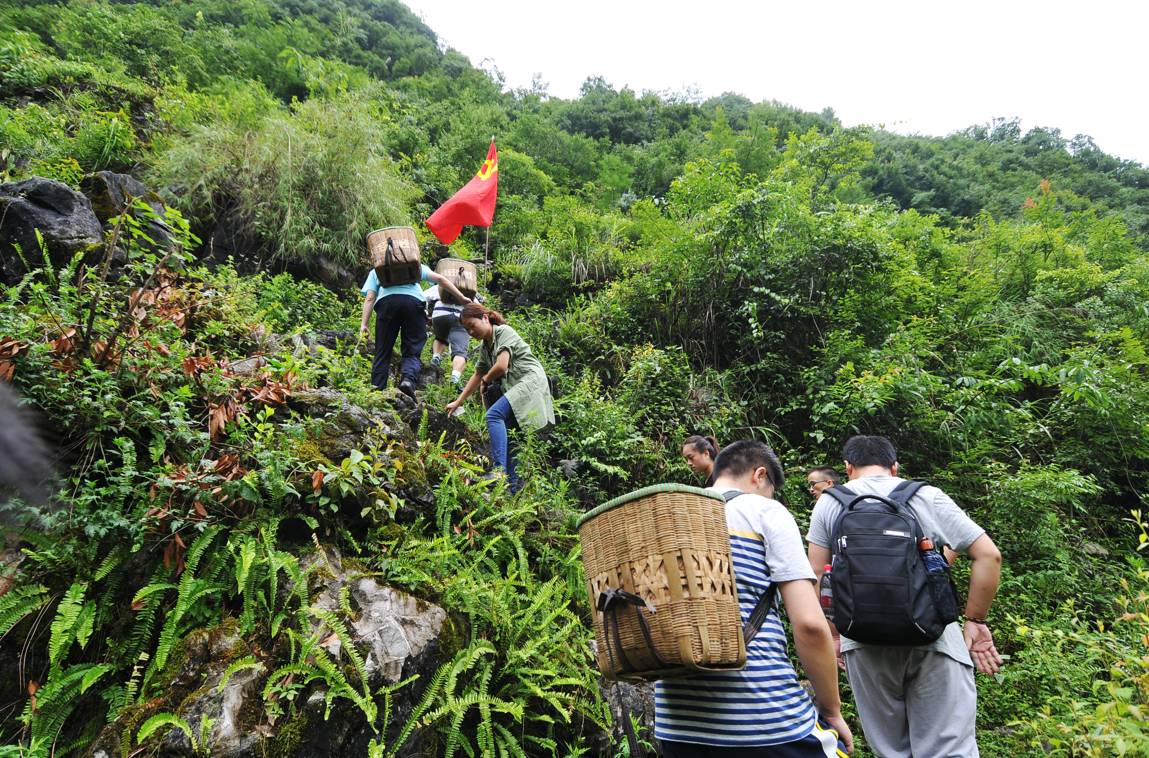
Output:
[{"xmin": 805, "ymin": 474, "xmax": 986, "ymax": 666}]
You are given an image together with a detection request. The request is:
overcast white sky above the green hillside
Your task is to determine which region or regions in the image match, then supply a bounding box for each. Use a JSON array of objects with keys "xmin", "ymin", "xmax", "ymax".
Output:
[{"xmin": 404, "ymin": 0, "xmax": 1149, "ymax": 165}]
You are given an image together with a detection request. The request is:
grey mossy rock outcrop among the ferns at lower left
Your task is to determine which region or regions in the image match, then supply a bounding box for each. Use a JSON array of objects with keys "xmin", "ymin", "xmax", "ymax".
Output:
[{"xmin": 86, "ymin": 548, "xmax": 448, "ymax": 758}]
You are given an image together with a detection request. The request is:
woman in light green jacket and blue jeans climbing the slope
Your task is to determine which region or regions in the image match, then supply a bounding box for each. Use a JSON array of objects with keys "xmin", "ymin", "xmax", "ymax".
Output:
[{"xmin": 446, "ymin": 302, "xmax": 555, "ymax": 492}]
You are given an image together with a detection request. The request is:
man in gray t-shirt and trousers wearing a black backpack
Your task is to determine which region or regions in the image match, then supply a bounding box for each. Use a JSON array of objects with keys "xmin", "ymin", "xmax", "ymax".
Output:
[{"xmin": 807, "ymin": 435, "xmax": 1002, "ymax": 758}]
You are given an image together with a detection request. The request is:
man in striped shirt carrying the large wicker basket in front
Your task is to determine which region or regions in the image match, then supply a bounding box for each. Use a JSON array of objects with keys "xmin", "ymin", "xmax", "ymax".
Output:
[{"xmin": 655, "ymin": 440, "xmax": 853, "ymax": 758}]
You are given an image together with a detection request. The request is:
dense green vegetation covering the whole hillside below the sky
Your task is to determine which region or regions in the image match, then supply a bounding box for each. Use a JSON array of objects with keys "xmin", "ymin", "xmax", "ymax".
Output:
[{"xmin": 0, "ymin": 0, "xmax": 1149, "ymax": 756}]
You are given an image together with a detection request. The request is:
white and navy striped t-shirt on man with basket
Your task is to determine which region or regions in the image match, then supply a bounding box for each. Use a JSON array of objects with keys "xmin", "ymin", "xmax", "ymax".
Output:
[{"xmin": 655, "ymin": 490, "xmax": 816, "ymax": 747}]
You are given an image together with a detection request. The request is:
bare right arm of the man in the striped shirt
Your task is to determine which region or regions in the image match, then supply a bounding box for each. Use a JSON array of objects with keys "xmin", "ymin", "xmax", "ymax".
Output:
[{"xmin": 778, "ymin": 579, "xmax": 854, "ymax": 751}]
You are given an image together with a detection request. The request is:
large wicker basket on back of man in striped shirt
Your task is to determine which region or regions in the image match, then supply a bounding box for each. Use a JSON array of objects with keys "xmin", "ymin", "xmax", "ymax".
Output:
[{"xmin": 578, "ymin": 485, "xmax": 746, "ymax": 680}]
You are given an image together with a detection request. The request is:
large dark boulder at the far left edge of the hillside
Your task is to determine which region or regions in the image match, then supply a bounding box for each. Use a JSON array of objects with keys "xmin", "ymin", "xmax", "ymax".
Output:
[{"xmin": 0, "ymin": 177, "xmax": 103, "ymax": 285}]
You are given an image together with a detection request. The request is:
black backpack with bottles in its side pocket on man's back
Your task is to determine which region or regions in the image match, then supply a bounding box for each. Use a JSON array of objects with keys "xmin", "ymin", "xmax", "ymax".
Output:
[{"xmin": 825, "ymin": 481, "xmax": 957, "ymax": 645}]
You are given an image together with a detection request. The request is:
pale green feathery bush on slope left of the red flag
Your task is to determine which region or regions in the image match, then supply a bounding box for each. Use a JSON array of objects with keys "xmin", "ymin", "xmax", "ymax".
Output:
[{"xmin": 152, "ymin": 83, "xmax": 414, "ymax": 266}]
